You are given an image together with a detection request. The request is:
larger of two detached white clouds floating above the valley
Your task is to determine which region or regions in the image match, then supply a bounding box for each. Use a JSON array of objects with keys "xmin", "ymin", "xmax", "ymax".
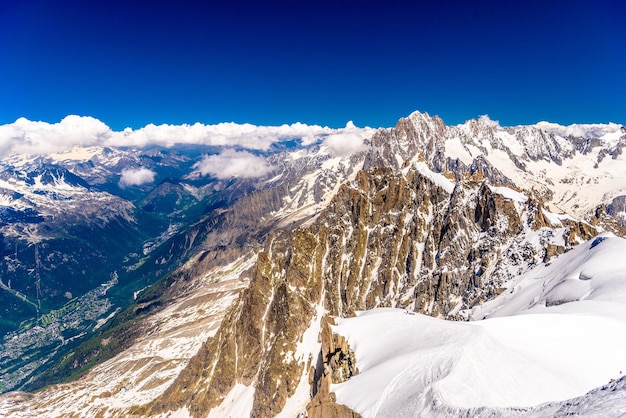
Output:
[{"xmin": 193, "ymin": 149, "xmax": 273, "ymax": 179}]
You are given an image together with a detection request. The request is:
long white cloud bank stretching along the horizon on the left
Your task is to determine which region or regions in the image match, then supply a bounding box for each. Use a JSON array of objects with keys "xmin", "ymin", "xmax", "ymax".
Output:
[{"xmin": 0, "ymin": 115, "xmax": 374, "ymax": 158}]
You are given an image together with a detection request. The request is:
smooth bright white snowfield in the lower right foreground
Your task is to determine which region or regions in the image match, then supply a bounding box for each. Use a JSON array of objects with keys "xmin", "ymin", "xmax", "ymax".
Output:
[{"xmin": 331, "ymin": 234, "xmax": 626, "ymax": 417}]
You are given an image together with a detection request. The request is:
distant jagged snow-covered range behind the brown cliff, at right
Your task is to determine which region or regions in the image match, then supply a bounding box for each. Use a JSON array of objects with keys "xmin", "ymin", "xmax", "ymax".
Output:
[{"xmin": 373, "ymin": 112, "xmax": 626, "ymax": 221}]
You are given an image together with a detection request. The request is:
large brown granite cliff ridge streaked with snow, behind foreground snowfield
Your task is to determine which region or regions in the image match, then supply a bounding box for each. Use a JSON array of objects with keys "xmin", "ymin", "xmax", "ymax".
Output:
[{"xmin": 133, "ymin": 159, "xmax": 595, "ymax": 417}]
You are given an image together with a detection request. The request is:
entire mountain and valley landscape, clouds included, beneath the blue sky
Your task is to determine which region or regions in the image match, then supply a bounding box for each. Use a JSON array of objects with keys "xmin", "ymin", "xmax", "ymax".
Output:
[{"xmin": 0, "ymin": 112, "xmax": 626, "ymax": 418}]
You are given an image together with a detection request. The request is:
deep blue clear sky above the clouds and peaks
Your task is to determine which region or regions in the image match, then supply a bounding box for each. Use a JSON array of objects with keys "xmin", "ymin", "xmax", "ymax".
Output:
[{"xmin": 0, "ymin": 0, "xmax": 626, "ymax": 130}]
